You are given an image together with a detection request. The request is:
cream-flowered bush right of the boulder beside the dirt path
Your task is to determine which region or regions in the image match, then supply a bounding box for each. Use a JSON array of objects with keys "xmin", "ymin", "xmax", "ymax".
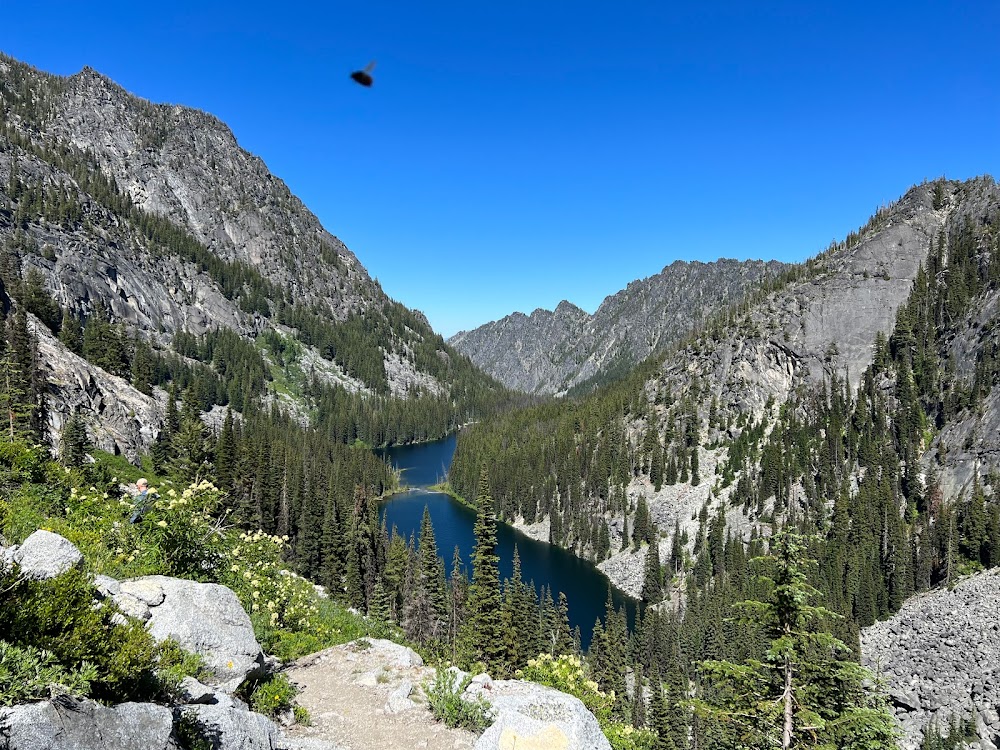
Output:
[{"xmin": 517, "ymin": 654, "xmax": 656, "ymax": 750}]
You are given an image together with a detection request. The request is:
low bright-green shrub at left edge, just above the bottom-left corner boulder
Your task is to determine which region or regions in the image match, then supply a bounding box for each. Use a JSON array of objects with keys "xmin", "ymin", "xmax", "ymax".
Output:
[{"xmin": 0, "ymin": 641, "xmax": 97, "ymax": 706}]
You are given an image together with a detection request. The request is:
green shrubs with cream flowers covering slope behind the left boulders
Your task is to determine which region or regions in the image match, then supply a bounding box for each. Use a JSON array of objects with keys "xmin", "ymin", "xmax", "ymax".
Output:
[{"xmin": 0, "ymin": 445, "xmax": 380, "ymax": 660}]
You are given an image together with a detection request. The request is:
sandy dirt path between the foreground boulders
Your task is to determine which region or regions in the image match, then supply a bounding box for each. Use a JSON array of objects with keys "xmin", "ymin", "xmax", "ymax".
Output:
[{"xmin": 285, "ymin": 640, "xmax": 476, "ymax": 750}]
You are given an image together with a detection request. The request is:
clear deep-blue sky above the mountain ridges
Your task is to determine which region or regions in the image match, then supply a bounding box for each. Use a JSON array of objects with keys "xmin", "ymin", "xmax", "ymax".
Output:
[{"xmin": 0, "ymin": 0, "xmax": 1000, "ymax": 335}]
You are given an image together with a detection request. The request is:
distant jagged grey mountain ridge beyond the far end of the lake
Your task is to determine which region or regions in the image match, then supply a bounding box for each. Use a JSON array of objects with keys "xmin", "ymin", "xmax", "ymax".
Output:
[{"xmin": 448, "ymin": 258, "xmax": 786, "ymax": 394}]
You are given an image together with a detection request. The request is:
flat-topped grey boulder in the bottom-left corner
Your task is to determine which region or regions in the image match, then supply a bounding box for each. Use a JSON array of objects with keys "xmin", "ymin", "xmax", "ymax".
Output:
[{"xmin": 0, "ymin": 696, "xmax": 179, "ymax": 750}]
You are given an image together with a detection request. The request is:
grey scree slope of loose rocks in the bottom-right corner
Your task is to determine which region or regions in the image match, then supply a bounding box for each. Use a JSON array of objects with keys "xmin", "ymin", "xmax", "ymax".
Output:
[{"xmin": 861, "ymin": 569, "xmax": 1000, "ymax": 750}]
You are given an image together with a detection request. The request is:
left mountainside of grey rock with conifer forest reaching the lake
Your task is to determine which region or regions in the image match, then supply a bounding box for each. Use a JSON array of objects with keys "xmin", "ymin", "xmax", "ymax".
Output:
[{"xmin": 0, "ymin": 57, "xmax": 509, "ymax": 624}]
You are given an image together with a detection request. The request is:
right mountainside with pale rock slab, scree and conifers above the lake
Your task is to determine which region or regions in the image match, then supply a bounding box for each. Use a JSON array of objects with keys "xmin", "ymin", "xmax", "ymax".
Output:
[{"xmin": 450, "ymin": 178, "xmax": 1000, "ymax": 746}]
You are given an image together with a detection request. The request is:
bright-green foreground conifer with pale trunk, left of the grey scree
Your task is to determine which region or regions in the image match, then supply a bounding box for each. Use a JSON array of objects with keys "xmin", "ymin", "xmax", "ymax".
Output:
[{"xmin": 693, "ymin": 531, "xmax": 895, "ymax": 750}]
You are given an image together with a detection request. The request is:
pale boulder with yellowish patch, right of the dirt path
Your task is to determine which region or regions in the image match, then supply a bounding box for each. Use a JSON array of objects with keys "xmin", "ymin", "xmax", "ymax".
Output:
[{"xmin": 466, "ymin": 680, "xmax": 611, "ymax": 750}]
